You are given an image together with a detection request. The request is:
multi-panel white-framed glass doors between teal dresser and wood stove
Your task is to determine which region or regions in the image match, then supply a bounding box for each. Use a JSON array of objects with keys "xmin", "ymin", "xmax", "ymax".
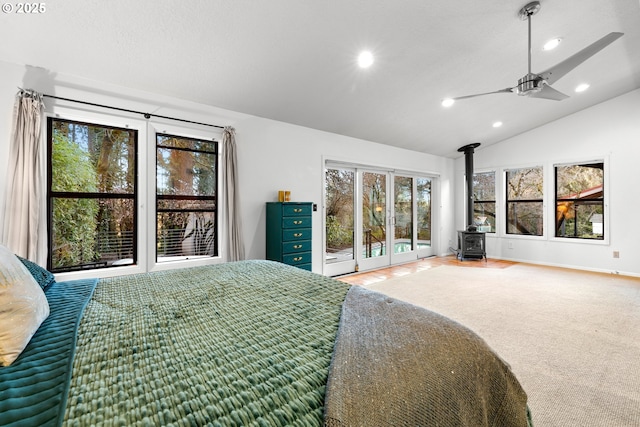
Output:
[{"xmin": 323, "ymin": 166, "xmax": 433, "ymax": 276}]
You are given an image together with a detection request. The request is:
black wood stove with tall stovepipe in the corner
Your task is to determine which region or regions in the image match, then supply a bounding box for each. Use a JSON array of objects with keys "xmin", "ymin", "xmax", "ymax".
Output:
[{"xmin": 456, "ymin": 142, "xmax": 487, "ymax": 261}]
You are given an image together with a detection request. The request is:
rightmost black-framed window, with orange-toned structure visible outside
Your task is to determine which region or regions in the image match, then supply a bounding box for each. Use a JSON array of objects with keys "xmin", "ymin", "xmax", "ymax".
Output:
[{"xmin": 555, "ymin": 161, "xmax": 604, "ymax": 240}]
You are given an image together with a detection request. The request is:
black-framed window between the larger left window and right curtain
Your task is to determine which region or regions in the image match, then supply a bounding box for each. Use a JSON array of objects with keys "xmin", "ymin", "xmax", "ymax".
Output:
[{"xmin": 156, "ymin": 134, "xmax": 218, "ymax": 262}]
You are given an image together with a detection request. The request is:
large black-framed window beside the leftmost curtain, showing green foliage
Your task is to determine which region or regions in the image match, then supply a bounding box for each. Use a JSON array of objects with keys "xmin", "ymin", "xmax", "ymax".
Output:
[{"xmin": 47, "ymin": 118, "xmax": 138, "ymax": 272}]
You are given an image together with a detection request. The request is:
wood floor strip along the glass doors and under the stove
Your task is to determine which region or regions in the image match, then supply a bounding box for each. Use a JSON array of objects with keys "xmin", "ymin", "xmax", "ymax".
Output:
[{"xmin": 335, "ymin": 255, "xmax": 516, "ymax": 286}]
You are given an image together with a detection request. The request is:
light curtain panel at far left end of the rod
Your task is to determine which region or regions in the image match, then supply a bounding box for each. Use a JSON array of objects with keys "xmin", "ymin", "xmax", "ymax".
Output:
[{"xmin": 2, "ymin": 89, "xmax": 47, "ymax": 266}]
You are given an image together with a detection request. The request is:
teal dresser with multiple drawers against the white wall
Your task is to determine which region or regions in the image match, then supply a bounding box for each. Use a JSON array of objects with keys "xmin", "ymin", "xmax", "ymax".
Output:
[{"xmin": 267, "ymin": 202, "xmax": 313, "ymax": 271}]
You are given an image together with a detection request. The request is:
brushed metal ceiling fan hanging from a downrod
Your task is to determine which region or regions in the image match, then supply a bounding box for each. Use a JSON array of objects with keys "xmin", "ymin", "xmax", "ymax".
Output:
[{"xmin": 442, "ymin": 1, "xmax": 624, "ymax": 106}]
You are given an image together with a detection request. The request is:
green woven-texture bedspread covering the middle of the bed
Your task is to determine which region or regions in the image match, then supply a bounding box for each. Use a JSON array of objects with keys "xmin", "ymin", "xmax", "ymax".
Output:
[{"xmin": 65, "ymin": 261, "xmax": 349, "ymax": 426}]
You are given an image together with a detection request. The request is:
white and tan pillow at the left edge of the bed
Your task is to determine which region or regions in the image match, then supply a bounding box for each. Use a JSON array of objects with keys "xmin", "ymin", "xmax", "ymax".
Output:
[{"xmin": 0, "ymin": 245, "xmax": 49, "ymax": 366}]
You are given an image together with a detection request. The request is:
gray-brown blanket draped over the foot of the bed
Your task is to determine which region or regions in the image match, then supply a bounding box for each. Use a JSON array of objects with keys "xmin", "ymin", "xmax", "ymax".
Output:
[{"xmin": 325, "ymin": 286, "xmax": 530, "ymax": 427}]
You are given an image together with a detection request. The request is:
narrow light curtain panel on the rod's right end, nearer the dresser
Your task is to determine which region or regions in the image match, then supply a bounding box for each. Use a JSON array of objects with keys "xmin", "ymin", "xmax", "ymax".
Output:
[{"xmin": 222, "ymin": 126, "xmax": 244, "ymax": 261}]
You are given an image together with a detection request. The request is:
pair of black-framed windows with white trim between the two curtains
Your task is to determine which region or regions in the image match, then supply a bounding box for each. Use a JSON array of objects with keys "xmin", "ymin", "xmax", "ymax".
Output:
[{"xmin": 47, "ymin": 112, "xmax": 220, "ymax": 277}]
